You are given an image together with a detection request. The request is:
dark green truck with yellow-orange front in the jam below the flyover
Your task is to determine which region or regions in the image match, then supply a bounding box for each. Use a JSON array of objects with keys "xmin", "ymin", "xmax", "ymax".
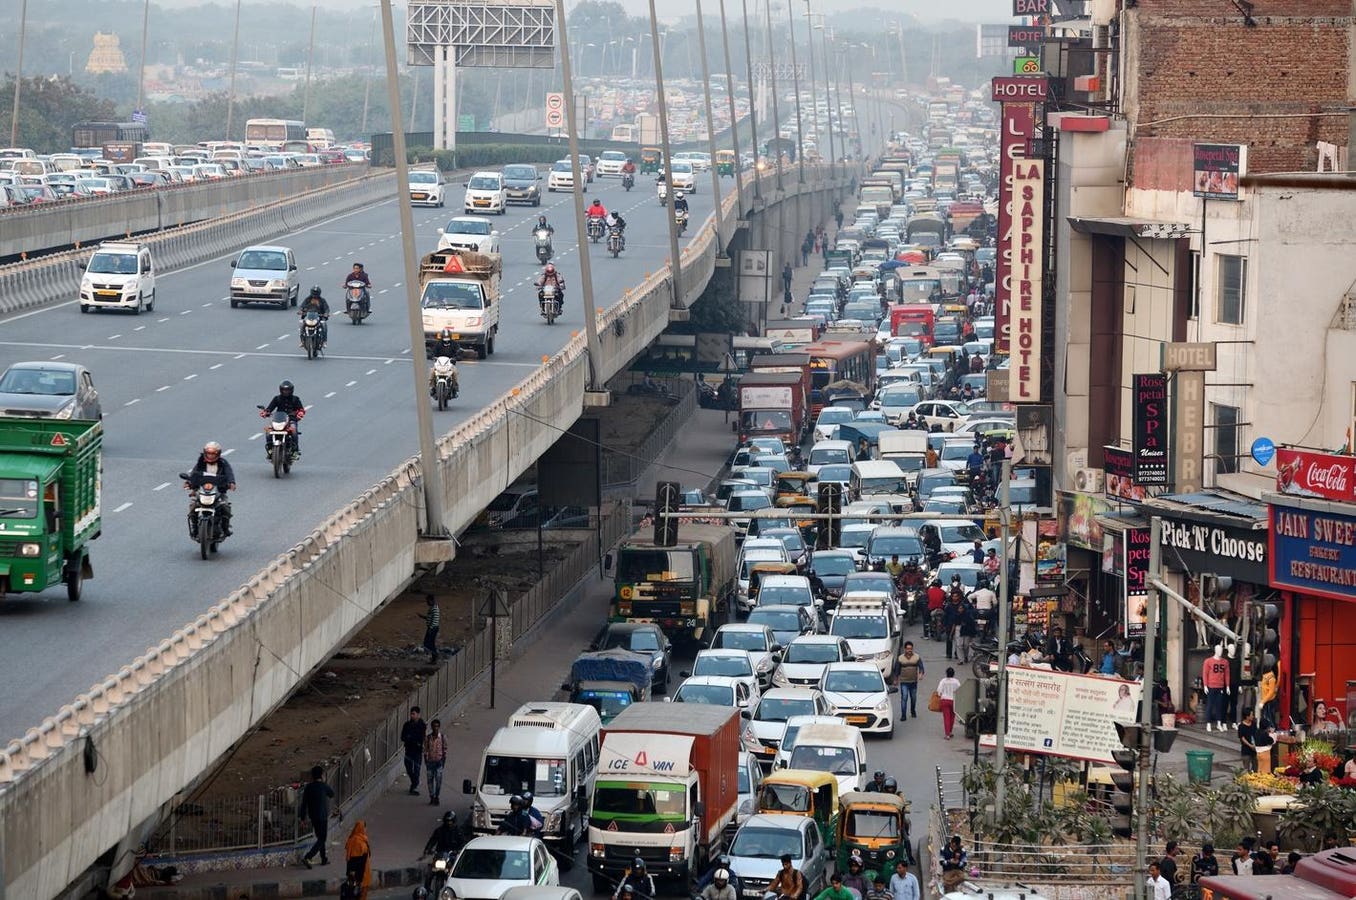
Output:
[{"xmin": 609, "ymin": 522, "xmax": 738, "ymax": 641}]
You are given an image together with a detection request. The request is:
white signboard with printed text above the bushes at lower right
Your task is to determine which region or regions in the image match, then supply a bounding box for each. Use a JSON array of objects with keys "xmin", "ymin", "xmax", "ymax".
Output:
[{"xmin": 1006, "ymin": 666, "xmax": 1142, "ymax": 764}]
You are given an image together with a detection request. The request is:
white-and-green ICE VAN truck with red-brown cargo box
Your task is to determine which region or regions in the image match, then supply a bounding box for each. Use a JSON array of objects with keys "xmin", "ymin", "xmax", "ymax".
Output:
[{"xmin": 589, "ymin": 703, "xmax": 742, "ymax": 895}]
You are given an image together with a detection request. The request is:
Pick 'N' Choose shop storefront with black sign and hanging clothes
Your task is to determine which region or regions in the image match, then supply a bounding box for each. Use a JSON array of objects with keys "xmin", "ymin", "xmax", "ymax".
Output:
[{"xmin": 1138, "ymin": 489, "xmax": 1274, "ymax": 727}]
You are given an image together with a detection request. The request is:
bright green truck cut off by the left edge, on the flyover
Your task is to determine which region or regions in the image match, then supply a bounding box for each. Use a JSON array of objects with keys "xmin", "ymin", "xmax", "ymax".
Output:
[{"xmin": 0, "ymin": 417, "xmax": 103, "ymax": 602}]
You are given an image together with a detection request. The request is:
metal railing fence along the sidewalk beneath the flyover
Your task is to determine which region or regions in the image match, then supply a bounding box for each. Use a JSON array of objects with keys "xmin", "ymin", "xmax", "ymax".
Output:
[{"xmin": 152, "ymin": 502, "xmax": 631, "ymax": 855}]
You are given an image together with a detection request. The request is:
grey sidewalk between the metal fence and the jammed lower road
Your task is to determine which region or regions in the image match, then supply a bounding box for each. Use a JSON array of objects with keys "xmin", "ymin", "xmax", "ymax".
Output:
[{"xmin": 137, "ymin": 409, "xmax": 734, "ymax": 900}]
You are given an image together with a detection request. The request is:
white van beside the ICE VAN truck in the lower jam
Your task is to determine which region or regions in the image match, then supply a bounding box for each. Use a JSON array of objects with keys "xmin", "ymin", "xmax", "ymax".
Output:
[{"xmin": 461, "ymin": 701, "xmax": 602, "ymax": 855}]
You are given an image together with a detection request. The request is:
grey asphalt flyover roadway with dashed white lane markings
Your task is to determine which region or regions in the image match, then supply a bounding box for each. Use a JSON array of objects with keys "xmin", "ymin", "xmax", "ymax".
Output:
[{"xmin": 0, "ymin": 165, "xmax": 732, "ymax": 741}]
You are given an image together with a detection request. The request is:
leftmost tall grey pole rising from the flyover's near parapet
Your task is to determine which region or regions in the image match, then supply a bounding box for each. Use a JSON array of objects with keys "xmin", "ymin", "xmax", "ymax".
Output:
[{"xmin": 376, "ymin": 0, "xmax": 450, "ymax": 534}]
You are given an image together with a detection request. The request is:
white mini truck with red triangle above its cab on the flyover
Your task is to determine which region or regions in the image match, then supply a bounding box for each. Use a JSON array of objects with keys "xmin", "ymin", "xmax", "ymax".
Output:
[{"xmin": 419, "ymin": 249, "xmax": 500, "ymax": 359}]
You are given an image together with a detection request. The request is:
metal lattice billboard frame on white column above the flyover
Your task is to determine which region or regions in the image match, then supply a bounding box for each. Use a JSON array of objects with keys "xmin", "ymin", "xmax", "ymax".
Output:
[{"xmin": 405, "ymin": 0, "xmax": 556, "ymax": 149}]
